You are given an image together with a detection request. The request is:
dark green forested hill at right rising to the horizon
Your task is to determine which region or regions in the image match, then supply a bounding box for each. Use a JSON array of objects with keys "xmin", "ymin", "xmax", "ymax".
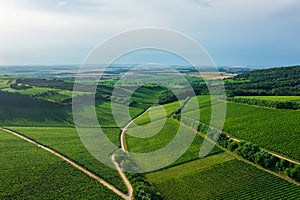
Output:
[{"xmin": 226, "ymin": 66, "xmax": 300, "ymax": 96}]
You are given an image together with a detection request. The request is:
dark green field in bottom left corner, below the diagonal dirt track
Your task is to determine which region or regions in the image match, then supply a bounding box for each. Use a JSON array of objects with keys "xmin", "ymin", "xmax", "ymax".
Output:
[{"xmin": 0, "ymin": 131, "xmax": 122, "ymax": 200}]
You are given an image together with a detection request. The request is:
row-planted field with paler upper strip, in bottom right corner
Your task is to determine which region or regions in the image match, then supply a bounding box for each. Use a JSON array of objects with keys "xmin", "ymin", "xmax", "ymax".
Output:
[{"xmin": 146, "ymin": 153, "xmax": 300, "ymax": 199}]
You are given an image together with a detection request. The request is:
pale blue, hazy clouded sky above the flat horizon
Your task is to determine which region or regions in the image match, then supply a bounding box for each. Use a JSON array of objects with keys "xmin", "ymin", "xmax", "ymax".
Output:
[{"xmin": 0, "ymin": 0, "xmax": 300, "ymax": 66}]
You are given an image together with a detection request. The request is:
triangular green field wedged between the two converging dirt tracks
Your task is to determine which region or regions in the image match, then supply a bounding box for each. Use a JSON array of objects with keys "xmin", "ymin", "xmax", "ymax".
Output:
[{"xmin": 8, "ymin": 127, "xmax": 127, "ymax": 191}]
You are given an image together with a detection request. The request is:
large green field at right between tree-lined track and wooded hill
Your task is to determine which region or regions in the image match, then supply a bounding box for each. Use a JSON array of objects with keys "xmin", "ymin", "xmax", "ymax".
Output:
[{"xmin": 184, "ymin": 103, "xmax": 300, "ymax": 160}]
